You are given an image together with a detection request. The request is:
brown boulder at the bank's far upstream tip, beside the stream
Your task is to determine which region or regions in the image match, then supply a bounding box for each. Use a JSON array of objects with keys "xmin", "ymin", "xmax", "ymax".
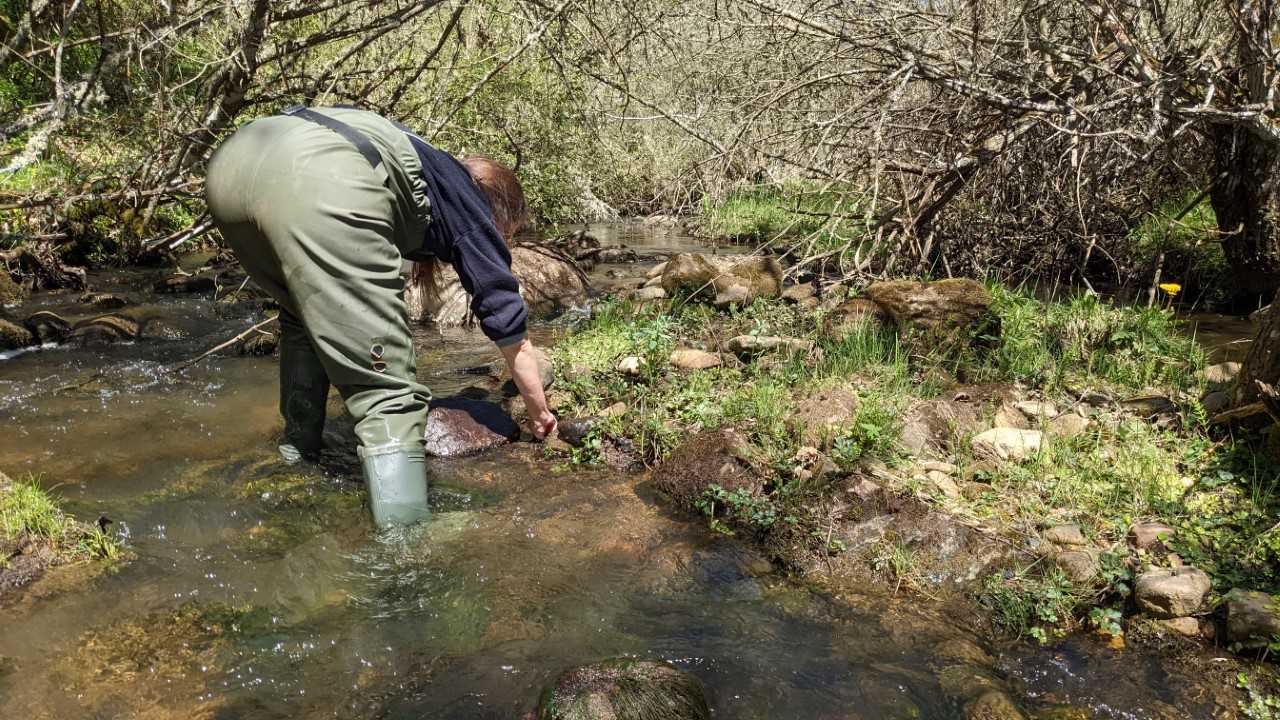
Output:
[{"xmin": 662, "ymin": 252, "xmax": 782, "ymax": 306}]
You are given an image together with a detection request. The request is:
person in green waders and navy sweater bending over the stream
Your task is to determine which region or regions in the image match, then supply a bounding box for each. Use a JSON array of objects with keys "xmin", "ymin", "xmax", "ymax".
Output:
[{"xmin": 206, "ymin": 106, "xmax": 556, "ymax": 527}]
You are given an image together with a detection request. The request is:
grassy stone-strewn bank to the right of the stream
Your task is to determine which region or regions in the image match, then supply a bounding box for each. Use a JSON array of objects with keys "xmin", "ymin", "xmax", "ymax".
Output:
[{"xmin": 554, "ymin": 286, "xmax": 1280, "ymax": 650}]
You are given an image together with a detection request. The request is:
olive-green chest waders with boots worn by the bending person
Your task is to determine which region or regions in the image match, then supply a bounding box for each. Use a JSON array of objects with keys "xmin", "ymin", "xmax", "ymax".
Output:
[{"xmin": 218, "ymin": 106, "xmax": 430, "ymax": 528}]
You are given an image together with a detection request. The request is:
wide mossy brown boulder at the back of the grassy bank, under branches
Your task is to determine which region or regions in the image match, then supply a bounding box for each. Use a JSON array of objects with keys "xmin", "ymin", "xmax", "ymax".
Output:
[{"xmin": 867, "ymin": 278, "xmax": 991, "ymax": 332}]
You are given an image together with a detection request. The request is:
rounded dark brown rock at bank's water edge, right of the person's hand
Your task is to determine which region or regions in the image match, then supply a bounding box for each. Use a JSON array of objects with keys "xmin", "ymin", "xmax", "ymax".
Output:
[{"xmin": 653, "ymin": 428, "xmax": 765, "ymax": 510}]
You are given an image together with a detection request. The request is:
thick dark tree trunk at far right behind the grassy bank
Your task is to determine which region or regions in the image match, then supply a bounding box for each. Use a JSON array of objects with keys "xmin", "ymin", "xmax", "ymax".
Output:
[{"xmin": 1210, "ymin": 126, "xmax": 1280, "ymax": 302}]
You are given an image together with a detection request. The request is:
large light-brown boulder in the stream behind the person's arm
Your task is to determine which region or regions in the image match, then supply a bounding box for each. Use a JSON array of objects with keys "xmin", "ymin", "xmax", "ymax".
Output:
[{"xmin": 404, "ymin": 243, "xmax": 590, "ymax": 325}]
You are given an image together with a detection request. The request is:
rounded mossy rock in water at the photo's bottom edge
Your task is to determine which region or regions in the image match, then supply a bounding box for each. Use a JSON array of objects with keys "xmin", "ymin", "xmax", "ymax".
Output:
[{"xmin": 538, "ymin": 657, "xmax": 710, "ymax": 720}]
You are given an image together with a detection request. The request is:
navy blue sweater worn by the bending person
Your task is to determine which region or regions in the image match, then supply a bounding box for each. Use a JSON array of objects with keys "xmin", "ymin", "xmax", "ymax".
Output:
[{"xmin": 406, "ymin": 133, "xmax": 529, "ymax": 347}]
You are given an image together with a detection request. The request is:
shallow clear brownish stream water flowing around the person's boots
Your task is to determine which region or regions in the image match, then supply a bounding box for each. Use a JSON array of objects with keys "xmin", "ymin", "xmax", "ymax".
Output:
[{"xmin": 0, "ymin": 222, "xmax": 1244, "ymax": 720}]
